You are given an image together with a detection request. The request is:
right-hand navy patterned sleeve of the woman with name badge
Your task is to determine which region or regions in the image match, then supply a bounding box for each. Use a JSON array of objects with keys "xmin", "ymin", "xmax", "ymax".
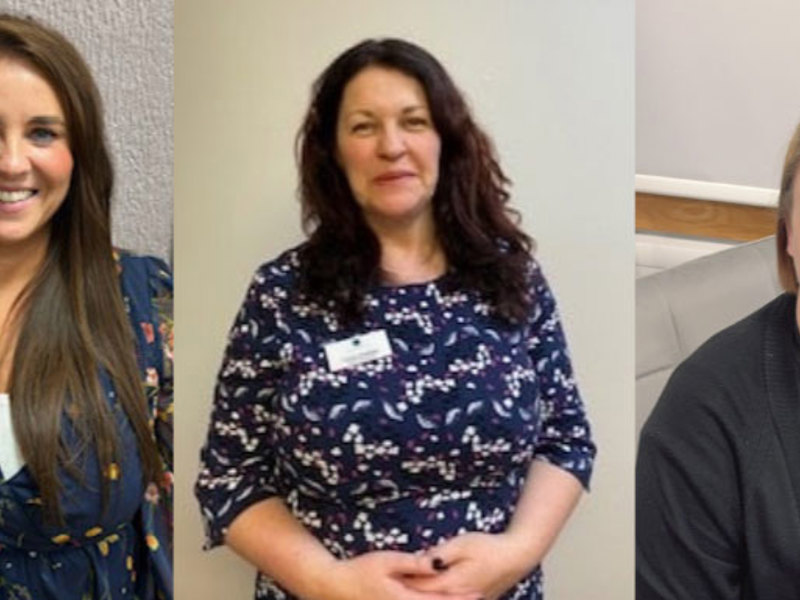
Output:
[{"xmin": 528, "ymin": 262, "xmax": 596, "ymax": 489}]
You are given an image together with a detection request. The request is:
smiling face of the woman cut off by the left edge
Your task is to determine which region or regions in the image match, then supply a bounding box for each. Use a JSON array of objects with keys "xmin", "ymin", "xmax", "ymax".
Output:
[{"xmin": 0, "ymin": 57, "xmax": 73, "ymax": 248}]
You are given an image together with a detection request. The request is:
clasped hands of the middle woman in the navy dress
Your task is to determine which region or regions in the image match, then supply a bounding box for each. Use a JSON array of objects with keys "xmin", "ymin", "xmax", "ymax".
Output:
[{"xmin": 332, "ymin": 533, "xmax": 532, "ymax": 600}]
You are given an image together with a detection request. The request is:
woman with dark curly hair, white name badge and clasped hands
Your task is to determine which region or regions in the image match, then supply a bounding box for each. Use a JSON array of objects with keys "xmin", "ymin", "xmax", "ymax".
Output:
[{"xmin": 196, "ymin": 39, "xmax": 595, "ymax": 600}]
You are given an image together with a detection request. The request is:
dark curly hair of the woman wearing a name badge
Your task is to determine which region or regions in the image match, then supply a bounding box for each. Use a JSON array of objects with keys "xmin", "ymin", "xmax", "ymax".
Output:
[{"xmin": 297, "ymin": 39, "xmax": 533, "ymax": 323}]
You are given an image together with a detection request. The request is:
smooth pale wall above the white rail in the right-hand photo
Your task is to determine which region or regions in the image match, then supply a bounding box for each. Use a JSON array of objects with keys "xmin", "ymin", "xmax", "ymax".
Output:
[{"xmin": 636, "ymin": 0, "xmax": 800, "ymax": 188}]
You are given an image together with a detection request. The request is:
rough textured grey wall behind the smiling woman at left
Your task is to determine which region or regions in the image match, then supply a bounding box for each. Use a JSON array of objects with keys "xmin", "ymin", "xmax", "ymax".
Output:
[{"xmin": 0, "ymin": 0, "xmax": 173, "ymax": 258}]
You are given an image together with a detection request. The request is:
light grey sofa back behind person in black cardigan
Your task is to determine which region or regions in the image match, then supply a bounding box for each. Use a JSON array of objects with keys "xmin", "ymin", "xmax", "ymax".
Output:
[{"xmin": 636, "ymin": 237, "xmax": 781, "ymax": 438}]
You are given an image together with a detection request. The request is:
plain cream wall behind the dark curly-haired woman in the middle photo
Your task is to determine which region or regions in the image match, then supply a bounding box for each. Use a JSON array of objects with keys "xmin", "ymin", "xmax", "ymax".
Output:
[{"xmin": 175, "ymin": 0, "xmax": 634, "ymax": 600}]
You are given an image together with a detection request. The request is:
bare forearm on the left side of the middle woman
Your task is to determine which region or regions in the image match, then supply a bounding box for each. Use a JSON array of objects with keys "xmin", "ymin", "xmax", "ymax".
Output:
[{"xmin": 225, "ymin": 497, "xmax": 336, "ymax": 600}]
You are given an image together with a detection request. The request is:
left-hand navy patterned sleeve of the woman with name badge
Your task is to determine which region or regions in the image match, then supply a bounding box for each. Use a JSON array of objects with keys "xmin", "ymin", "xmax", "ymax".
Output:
[{"xmin": 195, "ymin": 268, "xmax": 285, "ymax": 549}]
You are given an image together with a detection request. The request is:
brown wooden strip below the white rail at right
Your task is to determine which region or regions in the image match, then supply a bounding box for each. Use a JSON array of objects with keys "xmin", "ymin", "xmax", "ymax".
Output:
[{"xmin": 636, "ymin": 193, "xmax": 776, "ymax": 242}]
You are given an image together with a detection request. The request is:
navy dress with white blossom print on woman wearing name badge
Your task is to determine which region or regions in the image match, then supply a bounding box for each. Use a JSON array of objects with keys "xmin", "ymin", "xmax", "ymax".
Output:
[{"xmin": 196, "ymin": 249, "xmax": 595, "ymax": 600}]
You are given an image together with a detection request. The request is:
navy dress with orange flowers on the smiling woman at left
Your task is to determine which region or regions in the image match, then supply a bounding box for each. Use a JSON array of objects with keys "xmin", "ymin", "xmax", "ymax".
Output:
[{"xmin": 0, "ymin": 253, "xmax": 172, "ymax": 600}]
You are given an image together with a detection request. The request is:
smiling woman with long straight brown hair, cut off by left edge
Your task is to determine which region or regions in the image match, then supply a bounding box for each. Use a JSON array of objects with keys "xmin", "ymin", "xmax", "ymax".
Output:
[{"xmin": 0, "ymin": 14, "xmax": 172, "ymax": 600}]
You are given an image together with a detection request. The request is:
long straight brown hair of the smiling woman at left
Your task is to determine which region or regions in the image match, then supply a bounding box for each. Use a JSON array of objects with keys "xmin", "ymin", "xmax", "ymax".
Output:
[{"xmin": 0, "ymin": 14, "xmax": 160, "ymax": 522}]
